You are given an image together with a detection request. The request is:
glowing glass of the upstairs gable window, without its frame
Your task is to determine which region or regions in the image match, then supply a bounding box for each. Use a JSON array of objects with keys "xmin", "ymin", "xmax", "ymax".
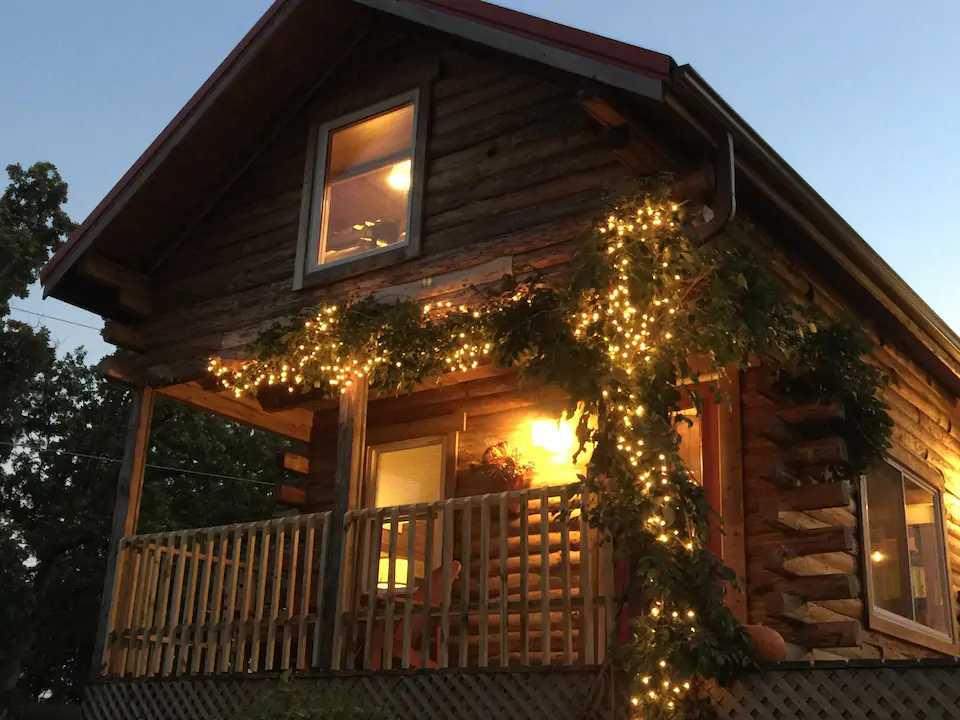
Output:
[{"xmin": 317, "ymin": 104, "xmax": 414, "ymax": 264}]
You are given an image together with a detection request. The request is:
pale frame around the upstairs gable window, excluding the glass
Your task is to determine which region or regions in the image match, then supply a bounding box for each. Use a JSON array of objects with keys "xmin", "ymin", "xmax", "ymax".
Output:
[{"xmin": 293, "ymin": 86, "xmax": 429, "ymax": 290}]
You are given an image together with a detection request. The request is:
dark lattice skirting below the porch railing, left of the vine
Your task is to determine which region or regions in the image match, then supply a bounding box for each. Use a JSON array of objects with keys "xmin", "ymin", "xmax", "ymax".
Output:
[{"xmin": 83, "ymin": 667, "xmax": 599, "ymax": 720}]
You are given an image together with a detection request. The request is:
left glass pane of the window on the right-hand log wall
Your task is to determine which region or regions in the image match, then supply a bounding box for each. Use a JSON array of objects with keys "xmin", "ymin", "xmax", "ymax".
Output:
[{"xmin": 867, "ymin": 463, "xmax": 914, "ymax": 620}]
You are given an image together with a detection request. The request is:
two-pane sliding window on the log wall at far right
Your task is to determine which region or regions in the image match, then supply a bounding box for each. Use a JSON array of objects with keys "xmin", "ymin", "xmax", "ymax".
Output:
[{"xmin": 863, "ymin": 463, "xmax": 953, "ymax": 638}]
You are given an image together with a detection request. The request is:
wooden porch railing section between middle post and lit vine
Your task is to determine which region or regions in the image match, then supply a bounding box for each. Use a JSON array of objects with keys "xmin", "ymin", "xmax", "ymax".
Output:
[{"xmin": 334, "ymin": 485, "xmax": 614, "ymax": 669}]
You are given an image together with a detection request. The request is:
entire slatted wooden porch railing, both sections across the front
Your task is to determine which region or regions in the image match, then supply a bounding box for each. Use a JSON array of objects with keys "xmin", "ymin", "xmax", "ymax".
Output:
[{"xmin": 102, "ymin": 485, "xmax": 613, "ymax": 678}]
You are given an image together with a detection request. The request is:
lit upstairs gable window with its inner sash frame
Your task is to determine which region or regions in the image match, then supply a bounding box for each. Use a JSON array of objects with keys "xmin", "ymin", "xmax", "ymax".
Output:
[{"xmin": 300, "ymin": 92, "xmax": 419, "ymax": 282}]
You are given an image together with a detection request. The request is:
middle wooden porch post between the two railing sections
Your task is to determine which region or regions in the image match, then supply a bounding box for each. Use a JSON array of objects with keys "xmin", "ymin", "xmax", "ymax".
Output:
[{"xmin": 320, "ymin": 378, "xmax": 369, "ymax": 668}]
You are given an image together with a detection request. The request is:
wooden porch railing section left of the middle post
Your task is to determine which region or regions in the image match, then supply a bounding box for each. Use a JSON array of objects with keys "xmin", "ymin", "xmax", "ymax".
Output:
[{"xmin": 103, "ymin": 513, "xmax": 330, "ymax": 677}]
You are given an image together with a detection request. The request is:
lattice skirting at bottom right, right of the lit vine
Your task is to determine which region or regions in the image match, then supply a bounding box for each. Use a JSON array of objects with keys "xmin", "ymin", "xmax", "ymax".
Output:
[{"xmin": 709, "ymin": 666, "xmax": 960, "ymax": 720}]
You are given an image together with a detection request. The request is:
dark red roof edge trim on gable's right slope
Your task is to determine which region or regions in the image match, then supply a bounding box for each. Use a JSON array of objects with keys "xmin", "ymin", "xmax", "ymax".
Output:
[{"xmin": 405, "ymin": 0, "xmax": 673, "ymax": 80}]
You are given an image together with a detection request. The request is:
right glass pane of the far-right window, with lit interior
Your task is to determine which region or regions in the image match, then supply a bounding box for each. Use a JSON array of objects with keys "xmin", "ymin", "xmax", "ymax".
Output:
[{"xmin": 903, "ymin": 478, "xmax": 950, "ymax": 634}]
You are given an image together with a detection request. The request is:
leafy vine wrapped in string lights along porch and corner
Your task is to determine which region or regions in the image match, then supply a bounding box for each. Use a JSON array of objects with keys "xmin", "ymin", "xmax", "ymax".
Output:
[{"xmin": 210, "ymin": 178, "xmax": 892, "ymax": 718}]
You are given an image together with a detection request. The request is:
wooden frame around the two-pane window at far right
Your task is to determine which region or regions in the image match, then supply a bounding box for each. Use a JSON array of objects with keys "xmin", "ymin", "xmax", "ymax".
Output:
[{"xmin": 860, "ymin": 457, "xmax": 960, "ymax": 655}]
